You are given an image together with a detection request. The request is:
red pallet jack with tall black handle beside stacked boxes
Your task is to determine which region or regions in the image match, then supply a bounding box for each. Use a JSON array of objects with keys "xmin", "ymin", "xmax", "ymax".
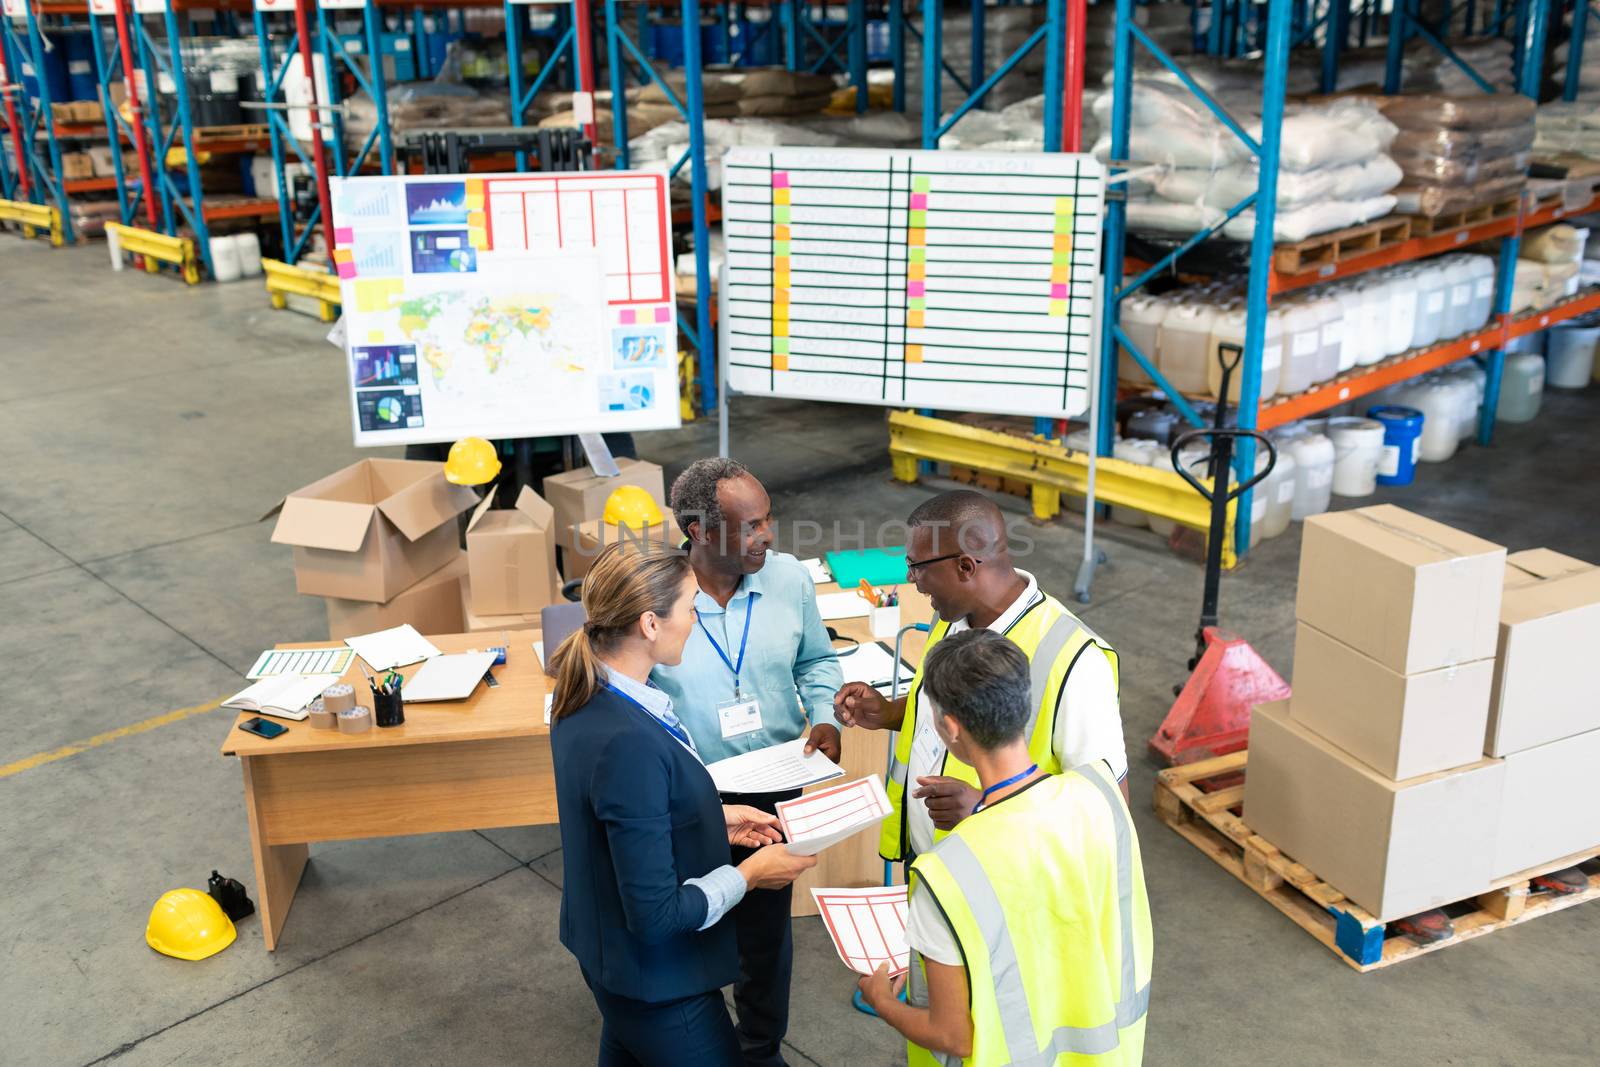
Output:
[{"xmin": 1150, "ymin": 344, "xmax": 1290, "ymax": 766}]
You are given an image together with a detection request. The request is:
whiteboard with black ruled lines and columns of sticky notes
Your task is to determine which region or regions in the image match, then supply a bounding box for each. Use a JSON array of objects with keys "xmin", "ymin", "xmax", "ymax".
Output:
[{"xmin": 722, "ymin": 147, "xmax": 1106, "ymax": 418}]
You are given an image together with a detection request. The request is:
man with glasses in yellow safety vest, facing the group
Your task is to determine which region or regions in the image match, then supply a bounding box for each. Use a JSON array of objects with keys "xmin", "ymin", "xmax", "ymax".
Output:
[{"xmin": 834, "ymin": 490, "xmax": 1128, "ymax": 862}]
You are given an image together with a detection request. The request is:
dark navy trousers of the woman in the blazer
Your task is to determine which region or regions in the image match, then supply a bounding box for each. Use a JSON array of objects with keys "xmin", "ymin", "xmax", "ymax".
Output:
[{"xmin": 584, "ymin": 971, "xmax": 741, "ymax": 1067}]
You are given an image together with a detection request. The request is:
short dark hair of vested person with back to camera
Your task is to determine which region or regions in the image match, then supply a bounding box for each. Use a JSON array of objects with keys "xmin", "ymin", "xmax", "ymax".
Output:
[{"xmin": 922, "ymin": 630, "xmax": 1032, "ymax": 750}]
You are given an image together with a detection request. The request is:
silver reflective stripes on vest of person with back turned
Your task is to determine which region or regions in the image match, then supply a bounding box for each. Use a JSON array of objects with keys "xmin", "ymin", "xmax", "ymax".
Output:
[{"xmin": 923, "ymin": 768, "xmax": 1150, "ymax": 1067}]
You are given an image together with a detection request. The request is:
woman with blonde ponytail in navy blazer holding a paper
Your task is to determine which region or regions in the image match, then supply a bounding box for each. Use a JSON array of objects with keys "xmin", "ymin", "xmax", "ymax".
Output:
[{"xmin": 550, "ymin": 544, "xmax": 816, "ymax": 1067}]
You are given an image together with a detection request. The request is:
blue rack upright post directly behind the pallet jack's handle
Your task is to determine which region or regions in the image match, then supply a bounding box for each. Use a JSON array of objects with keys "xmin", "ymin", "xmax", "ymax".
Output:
[{"xmin": 1218, "ymin": 0, "xmax": 1290, "ymax": 555}]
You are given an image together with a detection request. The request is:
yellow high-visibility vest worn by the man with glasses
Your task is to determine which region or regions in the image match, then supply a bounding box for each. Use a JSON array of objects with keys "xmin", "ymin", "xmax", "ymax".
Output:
[{"xmin": 878, "ymin": 593, "xmax": 1118, "ymax": 859}]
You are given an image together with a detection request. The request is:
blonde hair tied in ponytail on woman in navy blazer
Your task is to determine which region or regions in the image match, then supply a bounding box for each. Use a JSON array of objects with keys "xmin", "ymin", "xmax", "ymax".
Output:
[{"xmin": 550, "ymin": 541, "xmax": 690, "ymax": 723}]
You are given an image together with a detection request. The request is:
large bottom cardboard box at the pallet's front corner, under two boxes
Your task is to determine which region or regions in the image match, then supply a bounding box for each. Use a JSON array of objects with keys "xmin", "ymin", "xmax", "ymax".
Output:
[{"xmin": 1245, "ymin": 701, "xmax": 1506, "ymax": 921}]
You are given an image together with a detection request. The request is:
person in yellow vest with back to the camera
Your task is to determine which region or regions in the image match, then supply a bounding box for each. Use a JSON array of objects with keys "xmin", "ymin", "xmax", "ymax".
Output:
[{"xmin": 861, "ymin": 630, "xmax": 1152, "ymax": 1067}]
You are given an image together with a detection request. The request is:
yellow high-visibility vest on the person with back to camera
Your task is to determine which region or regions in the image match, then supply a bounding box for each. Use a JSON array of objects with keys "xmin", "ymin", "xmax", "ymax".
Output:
[{"xmin": 907, "ymin": 763, "xmax": 1154, "ymax": 1067}]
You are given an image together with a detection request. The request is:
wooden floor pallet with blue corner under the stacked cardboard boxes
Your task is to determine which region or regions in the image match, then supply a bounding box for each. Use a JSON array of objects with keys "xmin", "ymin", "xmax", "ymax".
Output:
[{"xmin": 1155, "ymin": 750, "xmax": 1600, "ymax": 973}]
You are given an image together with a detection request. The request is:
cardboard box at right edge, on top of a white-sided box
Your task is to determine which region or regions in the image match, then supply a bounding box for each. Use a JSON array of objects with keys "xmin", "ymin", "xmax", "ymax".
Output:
[{"xmin": 1483, "ymin": 549, "xmax": 1600, "ymax": 755}]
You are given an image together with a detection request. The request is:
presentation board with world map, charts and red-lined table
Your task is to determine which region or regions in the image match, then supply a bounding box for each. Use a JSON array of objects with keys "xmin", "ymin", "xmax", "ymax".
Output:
[{"xmin": 331, "ymin": 171, "xmax": 680, "ymax": 446}]
